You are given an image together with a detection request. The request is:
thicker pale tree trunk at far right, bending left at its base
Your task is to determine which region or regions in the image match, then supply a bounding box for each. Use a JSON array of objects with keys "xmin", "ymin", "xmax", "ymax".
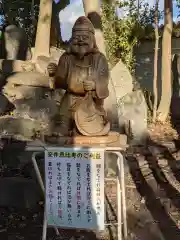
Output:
[{"xmin": 158, "ymin": 0, "xmax": 173, "ymax": 122}]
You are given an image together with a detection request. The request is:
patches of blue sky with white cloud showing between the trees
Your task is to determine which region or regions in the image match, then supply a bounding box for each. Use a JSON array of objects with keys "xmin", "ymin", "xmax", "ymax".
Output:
[{"xmin": 59, "ymin": 0, "xmax": 179, "ymax": 41}]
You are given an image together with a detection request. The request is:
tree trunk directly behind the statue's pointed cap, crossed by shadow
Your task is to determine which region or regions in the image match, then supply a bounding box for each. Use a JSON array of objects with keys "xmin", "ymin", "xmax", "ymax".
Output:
[{"xmin": 83, "ymin": 0, "xmax": 106, "ymax": 55}]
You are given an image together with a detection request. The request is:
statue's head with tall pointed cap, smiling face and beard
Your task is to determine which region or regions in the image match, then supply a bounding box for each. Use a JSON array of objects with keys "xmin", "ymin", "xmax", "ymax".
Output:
[{"xmin": 71, "ymin": 16, "xmax": 98, "ymax": 58}]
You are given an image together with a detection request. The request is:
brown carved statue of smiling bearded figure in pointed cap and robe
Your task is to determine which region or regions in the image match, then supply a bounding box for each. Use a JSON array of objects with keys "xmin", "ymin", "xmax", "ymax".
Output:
[{"xmin": 47, "ymin": 16, "xmax": 110, "ymax": 136}]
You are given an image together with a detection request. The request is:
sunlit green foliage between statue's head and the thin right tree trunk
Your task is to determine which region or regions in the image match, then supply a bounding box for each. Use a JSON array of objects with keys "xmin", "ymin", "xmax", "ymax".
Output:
[{"xmin": 102, "ymin": 0, "xmax": 161, "ymax": 72}]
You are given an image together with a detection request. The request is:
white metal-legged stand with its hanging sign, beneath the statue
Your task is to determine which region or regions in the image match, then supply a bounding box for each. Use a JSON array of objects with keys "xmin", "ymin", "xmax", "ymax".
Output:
[{"xmin": 28, "ymin": 147, "xmax": 128, "ymax": 240}]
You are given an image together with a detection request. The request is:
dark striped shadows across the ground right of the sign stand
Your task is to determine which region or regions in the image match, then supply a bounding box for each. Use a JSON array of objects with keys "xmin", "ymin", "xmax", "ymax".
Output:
[{"xmin": 127, "ymin": 141, "xmax": 180, "ymax": 240}]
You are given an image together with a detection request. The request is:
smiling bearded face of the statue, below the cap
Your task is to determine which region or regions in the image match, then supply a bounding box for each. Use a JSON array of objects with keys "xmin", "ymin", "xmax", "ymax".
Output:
[{"xmin": 71, "ymin": 31, "xmax": 94, "ymax": 58}]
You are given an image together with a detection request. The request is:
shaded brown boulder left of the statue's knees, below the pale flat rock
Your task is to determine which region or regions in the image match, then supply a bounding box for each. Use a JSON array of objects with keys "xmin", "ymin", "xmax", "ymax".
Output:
[{"xmin": 13, "ymin": 99, "xmax": 58, "ymax": 123}]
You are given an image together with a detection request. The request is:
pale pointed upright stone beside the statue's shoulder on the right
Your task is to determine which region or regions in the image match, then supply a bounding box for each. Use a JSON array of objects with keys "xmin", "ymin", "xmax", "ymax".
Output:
[{"xmin": 111, "ymin": 60, "xmax": 133, "ymax": 100}]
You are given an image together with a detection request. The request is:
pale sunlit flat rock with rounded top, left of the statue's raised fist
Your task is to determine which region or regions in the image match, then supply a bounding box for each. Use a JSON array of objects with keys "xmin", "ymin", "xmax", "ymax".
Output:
[{"xmin": 7, "ymin": 72, "xmax": 49, "ymax": 88}]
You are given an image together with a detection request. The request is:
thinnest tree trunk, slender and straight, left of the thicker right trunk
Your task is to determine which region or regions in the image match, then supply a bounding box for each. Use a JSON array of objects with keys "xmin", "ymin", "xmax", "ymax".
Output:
[{"xmin": 153, "ymin": 0, "xmax": 159, "ymax": 122}]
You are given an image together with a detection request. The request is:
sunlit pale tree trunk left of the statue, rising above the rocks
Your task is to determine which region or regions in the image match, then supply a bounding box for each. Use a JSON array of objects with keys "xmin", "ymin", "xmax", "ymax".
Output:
[{"xmin": 32, "ymin": 0, "xmax": 52, "ymax": 61}]
